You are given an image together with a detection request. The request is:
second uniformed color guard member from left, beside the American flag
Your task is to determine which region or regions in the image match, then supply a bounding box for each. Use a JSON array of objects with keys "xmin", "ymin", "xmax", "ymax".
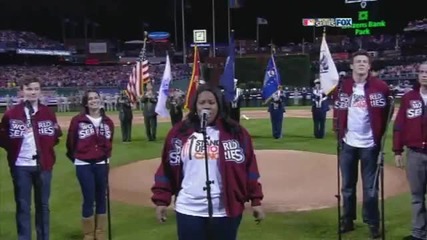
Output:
[{"xmin": 142, "ymin": 90, "xmax": 157, "ymax": 141}]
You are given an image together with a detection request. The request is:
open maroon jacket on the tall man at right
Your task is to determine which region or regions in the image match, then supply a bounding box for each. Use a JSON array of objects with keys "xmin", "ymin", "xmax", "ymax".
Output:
[{"xmin": 334, "ymin": 76, "xmax": 392, "ymax": 145}]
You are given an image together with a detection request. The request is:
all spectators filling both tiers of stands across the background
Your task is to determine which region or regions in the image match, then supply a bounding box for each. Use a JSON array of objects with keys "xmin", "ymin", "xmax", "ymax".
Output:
[{"xmin": 0, "ymin": 18, "xmax": 427, "ymax": 90}]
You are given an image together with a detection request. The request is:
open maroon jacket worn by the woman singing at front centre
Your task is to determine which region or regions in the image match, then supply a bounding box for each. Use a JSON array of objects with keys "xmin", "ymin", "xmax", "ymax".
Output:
[{"xmin": 151, "ymin": 118, "xmax": 264, "ymax": 217}]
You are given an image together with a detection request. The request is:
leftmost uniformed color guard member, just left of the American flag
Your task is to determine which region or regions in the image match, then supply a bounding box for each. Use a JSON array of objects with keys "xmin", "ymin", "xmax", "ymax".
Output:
[{"xmin": 117, "ymin": 94, "xmax": 133, "ymax": 142}]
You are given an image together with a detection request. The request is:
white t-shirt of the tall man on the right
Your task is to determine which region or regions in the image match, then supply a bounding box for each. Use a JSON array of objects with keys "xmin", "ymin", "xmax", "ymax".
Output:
[{"xmin": 343, "ymin": 82, "xmax": 375, "ymax": 148}]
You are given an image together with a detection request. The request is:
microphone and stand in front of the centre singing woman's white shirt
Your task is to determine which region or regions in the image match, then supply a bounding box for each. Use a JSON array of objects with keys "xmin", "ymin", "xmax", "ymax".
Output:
[{"xmin": 200, "ymin": 117, "xmax": 214, "ymax": 240}]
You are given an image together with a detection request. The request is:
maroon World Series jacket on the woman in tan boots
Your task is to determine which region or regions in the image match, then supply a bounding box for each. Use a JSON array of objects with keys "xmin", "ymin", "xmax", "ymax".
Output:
[{"xmin": 66, "ymin": 113, "xmax": 114, "ymax": 162}]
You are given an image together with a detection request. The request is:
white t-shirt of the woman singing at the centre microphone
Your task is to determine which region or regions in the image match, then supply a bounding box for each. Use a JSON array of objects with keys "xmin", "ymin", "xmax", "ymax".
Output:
[{"xmin": 175, "ymin": 127, "xmax": 227, "ymax": 217}]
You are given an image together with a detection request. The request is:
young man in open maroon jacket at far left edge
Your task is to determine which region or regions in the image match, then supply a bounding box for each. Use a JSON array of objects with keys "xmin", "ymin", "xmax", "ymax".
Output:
[{"xmin": 0, "ymin": 77, "xmax": 62, "ymax": 240}]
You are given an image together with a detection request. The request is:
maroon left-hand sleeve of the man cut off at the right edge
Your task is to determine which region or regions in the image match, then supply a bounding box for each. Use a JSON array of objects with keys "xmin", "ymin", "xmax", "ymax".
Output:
[{"xmin": 392, "ymin": 96, "xmax": 407, "ymax": 155}]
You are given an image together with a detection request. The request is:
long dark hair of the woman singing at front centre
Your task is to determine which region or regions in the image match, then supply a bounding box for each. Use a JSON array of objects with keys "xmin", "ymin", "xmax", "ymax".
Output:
[{"xmin": 181, "ymin": 84, "xmax": 240, "ymax": 133}]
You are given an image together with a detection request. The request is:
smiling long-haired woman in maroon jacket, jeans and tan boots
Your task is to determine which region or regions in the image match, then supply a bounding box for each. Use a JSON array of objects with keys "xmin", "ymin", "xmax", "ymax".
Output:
[{"xmin": 66, "ymin": 90, "xmax": 114, "ymax": 240}]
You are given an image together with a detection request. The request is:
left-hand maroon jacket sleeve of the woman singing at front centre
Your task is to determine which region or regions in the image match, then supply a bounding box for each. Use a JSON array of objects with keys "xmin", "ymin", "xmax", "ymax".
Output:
[{"xmin": 151, "ymin": 128, "xmax": 180, "ymax": 206}]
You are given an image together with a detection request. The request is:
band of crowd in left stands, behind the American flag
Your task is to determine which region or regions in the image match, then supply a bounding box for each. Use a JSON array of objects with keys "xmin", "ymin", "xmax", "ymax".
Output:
[{"xmin": 0, "ymin": 64, "xmax": 191, "ymax": 87}]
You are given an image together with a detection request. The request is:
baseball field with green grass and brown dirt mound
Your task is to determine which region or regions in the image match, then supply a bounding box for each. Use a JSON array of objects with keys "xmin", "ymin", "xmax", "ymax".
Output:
[{"xmin": 0, "ymin": 107, "xmax": 411, "ymax": 240}]
